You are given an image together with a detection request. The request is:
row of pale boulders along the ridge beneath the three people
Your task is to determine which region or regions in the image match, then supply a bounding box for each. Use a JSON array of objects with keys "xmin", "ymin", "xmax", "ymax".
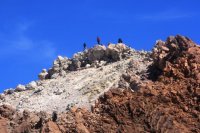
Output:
[{"xmin": 38, "ymin": 43, "xmax": 134, "ymax": 80}]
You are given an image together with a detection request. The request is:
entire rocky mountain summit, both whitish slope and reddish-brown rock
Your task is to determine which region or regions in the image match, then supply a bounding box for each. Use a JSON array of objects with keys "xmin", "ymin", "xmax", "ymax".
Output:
[{"xmin": 0, "ymin": 35, "xmax": 200, "ymax": 133}]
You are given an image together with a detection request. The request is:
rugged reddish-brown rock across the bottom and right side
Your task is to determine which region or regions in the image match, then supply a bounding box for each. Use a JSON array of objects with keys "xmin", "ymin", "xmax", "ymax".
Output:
[{"xmin": 0, "ymin": 36, "xmax": 200, "ymax": 133}]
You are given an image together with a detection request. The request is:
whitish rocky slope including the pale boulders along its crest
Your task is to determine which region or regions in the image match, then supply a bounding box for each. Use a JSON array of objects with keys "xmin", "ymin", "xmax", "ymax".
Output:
[{"xmin": 0, "ymin": 44, "xmax": 151, "ymax": 113}]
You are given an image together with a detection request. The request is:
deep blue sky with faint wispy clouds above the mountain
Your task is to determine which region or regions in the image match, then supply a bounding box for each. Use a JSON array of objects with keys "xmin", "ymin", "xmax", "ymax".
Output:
[{"xmin": 0, "ymin": 0, "xmax": 200, "ymax": 92}]
